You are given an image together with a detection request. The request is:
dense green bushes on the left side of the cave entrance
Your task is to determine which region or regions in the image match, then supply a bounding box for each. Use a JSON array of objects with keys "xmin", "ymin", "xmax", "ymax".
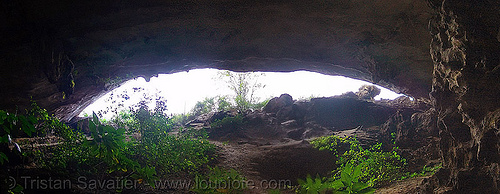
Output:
[{"xmin": 2, "ymin": 101, "xmax": 215, "ymax": 191}]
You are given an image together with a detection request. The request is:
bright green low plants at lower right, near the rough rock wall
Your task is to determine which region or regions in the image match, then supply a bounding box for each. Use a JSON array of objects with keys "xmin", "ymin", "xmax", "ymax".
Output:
[{"xmin": 298, "ymin": 136, "xmax": 441, "ymax": 193}]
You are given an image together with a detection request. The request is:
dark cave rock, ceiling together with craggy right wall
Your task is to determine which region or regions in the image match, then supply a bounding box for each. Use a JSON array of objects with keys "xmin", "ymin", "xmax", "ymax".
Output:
[{"xmin": 0, "ymin": 0, "xmax": 500, "ymax": 193}]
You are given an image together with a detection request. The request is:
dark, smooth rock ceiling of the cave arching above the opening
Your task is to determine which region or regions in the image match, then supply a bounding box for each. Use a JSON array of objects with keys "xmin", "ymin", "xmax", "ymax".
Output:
[{"xmin": 0, "ymin": 0, "xmax": 434, "ymax": 120}]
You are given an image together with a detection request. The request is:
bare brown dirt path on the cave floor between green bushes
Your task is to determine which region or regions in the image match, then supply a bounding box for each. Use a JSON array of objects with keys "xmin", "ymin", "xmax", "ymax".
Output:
[{"xmin": 211, "ymin": 140, "xmax": 425, "ymax": 194}]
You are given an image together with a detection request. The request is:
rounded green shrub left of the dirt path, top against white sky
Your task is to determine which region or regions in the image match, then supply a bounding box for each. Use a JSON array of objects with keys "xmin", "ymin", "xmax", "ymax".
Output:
[{"xmin": 119, "ymin": 104, "xmax": 215, "ymax": 176}]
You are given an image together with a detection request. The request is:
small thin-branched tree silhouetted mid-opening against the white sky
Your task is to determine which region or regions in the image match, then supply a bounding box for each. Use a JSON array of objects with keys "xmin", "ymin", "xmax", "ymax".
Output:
[{"xmin": 218, "ymin": 71, "xmax": 265, "ymax": 111}]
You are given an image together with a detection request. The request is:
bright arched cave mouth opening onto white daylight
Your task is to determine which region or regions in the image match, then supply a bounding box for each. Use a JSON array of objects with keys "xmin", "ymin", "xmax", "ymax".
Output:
[{"xmin": 79, "ymin": 68, "xmax": 403, "ymax": 118}]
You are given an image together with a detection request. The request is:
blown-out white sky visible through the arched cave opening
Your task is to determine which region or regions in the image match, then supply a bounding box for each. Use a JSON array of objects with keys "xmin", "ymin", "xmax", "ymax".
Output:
[{"xmin": 80, "ymin": 69, "xmax": 402, "ymax": 117}]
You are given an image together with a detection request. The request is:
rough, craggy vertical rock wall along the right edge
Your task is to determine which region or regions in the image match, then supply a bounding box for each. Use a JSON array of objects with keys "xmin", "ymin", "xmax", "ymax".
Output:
[{"xmin": 429, "ymin": 0, "xmax": 500, "ymax": 193}]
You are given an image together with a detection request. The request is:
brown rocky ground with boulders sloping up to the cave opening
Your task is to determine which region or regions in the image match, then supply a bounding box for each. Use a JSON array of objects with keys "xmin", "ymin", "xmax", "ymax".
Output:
[{"xmin": 189, "ymin": 94, "xmax": 439, "ymax": 193}]
